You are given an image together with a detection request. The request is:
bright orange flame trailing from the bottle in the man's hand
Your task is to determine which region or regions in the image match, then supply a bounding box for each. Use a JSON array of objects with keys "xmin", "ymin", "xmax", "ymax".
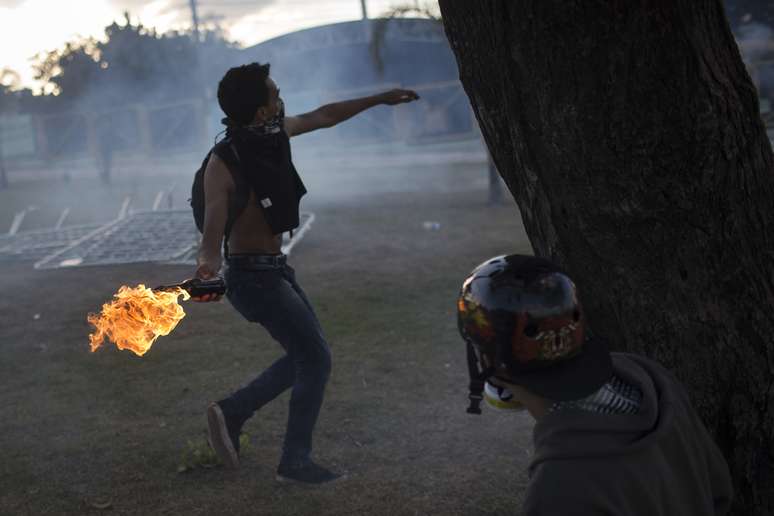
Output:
[{"xmin": 88, "ymin": 284, "xmax": 191, "ymax": 356}]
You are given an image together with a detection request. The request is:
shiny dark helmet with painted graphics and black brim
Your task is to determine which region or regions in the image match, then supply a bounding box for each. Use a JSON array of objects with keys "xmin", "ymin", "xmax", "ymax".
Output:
[{"xmin": 457, "ymin": 255, "xmax": 612, "ymax": 412}]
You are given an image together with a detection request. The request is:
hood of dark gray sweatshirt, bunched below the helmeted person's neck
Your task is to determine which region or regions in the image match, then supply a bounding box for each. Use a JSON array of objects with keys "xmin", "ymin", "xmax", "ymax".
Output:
[{"xmin": 529, "ymin": 353, "xmax": 676, "ymax": 475}]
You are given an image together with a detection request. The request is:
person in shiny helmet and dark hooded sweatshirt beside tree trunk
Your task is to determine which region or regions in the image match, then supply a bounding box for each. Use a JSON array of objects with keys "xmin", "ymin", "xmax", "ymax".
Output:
[{"xmin": 457, "ymin": 255, "xmax": 733, "ymax": 516}]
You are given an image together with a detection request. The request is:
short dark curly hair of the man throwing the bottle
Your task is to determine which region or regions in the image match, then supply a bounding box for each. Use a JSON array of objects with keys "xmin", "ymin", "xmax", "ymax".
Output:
[{"xmin": 218, "ymin": 63, "xmax": 270, "ymax": 124}]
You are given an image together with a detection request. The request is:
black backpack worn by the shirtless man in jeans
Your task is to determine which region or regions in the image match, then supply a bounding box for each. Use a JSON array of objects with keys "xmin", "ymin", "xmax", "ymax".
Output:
[{"xmin": 189, "ymin": 138, "xmax": 250, "ymax": 247}]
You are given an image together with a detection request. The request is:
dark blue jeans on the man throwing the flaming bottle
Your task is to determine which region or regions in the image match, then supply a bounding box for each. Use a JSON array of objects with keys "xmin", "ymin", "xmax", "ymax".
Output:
[{"xmin": 219, "ymin": 260, "xmax": 331, "ymax": 464}]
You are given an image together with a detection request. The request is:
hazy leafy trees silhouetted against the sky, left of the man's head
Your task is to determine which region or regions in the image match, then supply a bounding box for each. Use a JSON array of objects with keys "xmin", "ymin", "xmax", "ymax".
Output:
[{"xmin": 29, "ymin": 13, "xmax": 236, "ymax": 109}]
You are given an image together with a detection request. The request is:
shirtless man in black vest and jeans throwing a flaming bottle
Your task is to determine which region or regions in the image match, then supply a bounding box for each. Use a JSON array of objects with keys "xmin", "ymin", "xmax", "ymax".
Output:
[{"xmin": 196, "ymin": 63, "xmax": 419, "ymax": 484}]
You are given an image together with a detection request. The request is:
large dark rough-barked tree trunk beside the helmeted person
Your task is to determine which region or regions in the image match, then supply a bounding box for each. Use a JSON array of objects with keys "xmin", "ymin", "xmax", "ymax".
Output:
[{"xmin": 440, "ymin": 0, "xmax": 774, "ymax": 515}]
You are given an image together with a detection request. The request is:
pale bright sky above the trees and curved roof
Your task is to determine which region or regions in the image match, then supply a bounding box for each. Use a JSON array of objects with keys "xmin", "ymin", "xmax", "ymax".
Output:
[{"xmin": 0, "ymin": 0, "xmax": 400, "ymax": 89}]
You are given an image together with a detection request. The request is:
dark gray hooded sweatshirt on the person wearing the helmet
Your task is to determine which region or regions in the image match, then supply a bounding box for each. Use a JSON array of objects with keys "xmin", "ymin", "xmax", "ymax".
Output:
[{"xmin": 524, "ymin": 353, "xmax": 733, "ymax": 516}]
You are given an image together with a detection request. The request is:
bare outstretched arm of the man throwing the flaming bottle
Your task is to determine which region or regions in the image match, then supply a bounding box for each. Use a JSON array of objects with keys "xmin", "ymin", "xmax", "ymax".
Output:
[{"xmin": 285, "ymin": 89, "xmax": 419, "ymax": 136}]
